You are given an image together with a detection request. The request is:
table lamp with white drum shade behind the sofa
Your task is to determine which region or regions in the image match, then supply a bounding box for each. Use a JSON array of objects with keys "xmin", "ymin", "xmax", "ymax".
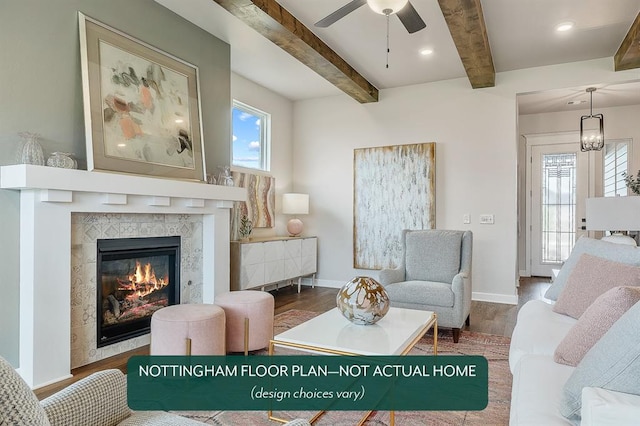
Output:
[{"xmin": 587, "ymin": 196, "xmax": 640, "ymax": 246}]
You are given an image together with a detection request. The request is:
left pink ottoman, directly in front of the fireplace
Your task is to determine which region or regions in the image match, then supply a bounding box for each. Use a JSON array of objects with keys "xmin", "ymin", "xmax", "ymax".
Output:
[{"xmin": 150, "ymin": 304, "xmax": 225, "ymax": 355}]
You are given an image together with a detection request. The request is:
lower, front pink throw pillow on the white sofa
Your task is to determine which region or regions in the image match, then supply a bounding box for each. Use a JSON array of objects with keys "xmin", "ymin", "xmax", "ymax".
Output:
[{"xmin": 553, "ymin": 287, "xmax": 640, "ymax": 367}]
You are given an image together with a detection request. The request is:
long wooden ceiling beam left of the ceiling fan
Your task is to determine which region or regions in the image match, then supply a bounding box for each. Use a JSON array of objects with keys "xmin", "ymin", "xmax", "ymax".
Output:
[{"xmin": 213, "ymin": 0, "xmax": 378, "ymax": 103}]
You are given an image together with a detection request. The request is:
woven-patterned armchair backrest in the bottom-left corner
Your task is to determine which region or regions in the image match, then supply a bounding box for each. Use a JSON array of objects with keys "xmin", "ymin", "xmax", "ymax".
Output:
[{"xmin": 0, "ymin": 357, "xmax": 50, "ymax": 426}]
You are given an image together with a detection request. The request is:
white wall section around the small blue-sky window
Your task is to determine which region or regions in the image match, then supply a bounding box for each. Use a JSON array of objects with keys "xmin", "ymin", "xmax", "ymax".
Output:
[{"xmin": 231, "ymin": 73, "xmax": 295, "ymax": 237}]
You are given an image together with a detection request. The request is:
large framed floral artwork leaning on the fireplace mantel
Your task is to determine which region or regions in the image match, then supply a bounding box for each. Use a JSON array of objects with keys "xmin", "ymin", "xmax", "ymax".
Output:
[{"xmin": 78, "ymin": 12, "xmax": 206, "ymax": 181}]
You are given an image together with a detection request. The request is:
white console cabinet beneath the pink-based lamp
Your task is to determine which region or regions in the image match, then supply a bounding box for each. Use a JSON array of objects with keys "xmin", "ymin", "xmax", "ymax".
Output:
[{"xmin": 231, "ymin": 237, "xmax": 318, "ymax": 293}]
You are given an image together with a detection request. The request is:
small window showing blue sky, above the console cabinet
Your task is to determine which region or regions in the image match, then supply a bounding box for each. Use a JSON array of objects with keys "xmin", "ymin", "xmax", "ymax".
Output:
[{"xmin": 231, "ymin": 100, "xmax": 271, "ymax": 171}]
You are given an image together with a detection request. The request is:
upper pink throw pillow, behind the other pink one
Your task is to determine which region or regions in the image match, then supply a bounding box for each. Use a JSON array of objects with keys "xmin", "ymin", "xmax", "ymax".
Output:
[{"xmin": 553, "ymin": 254, "xmax": 640, "ymax": 319}]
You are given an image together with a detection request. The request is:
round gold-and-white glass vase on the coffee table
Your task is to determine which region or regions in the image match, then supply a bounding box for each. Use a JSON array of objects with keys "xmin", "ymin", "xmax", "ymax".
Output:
[{"xmin": 336, "ymin": 277, "xmax": 391, "ymax": 325}]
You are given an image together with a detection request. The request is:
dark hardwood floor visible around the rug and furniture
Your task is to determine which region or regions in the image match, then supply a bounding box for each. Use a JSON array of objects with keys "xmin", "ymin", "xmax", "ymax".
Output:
[{"xmin": 35, "ymin": 277, "xmax": 550, "ymax": 399}]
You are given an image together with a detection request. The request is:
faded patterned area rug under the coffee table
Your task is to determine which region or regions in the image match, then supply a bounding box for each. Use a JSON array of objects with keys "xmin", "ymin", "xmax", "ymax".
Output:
[{"xmin": 177, "ymin": 310, "xmax": 511, "ymax": 426}]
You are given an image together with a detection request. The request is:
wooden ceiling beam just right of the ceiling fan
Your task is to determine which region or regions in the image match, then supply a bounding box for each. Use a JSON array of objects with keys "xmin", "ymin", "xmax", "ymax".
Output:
[{"xmin": 438, "ymin": 0, "xmax": 496, "ymax": 89}]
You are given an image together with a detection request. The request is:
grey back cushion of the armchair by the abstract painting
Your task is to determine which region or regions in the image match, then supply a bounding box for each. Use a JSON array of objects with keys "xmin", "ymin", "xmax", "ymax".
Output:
[{"xmin": 405, "ymin": 230, "xmax": 463, "ymax": 282}]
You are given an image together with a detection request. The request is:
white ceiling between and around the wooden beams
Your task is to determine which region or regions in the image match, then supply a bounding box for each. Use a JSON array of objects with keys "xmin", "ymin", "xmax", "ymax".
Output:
[{"xmin": 156, "ymin": 0, "xmax": 640, "ymax": 113}]
